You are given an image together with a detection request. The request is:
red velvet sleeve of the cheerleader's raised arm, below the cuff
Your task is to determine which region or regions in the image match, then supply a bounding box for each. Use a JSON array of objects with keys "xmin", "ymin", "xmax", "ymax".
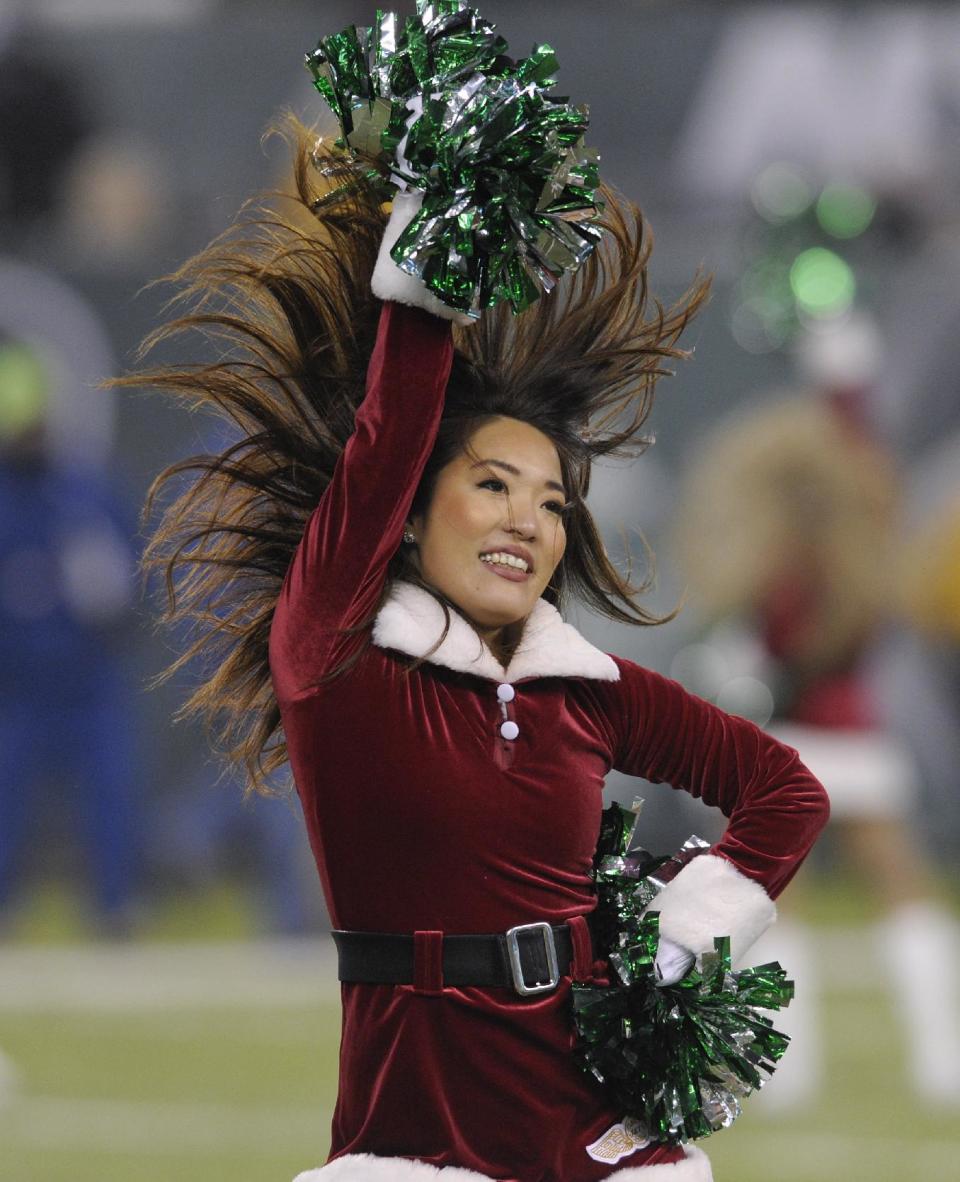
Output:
[{"xmin": 270, "ymin": 304, "xmax": 453, "ymax": 701}]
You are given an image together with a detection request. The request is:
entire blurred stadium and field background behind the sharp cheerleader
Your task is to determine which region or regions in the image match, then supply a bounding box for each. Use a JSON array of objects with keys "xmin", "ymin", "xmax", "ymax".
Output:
[{"xmin": 0, "ymin": 0, "xmax": 960, "ymax": 1182}]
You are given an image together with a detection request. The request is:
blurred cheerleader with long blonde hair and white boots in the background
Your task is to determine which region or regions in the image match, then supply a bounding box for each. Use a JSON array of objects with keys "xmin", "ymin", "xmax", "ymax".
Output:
[{"xmin": 676, "ymin": 318, "xmax": 960, "ymax": 1106}]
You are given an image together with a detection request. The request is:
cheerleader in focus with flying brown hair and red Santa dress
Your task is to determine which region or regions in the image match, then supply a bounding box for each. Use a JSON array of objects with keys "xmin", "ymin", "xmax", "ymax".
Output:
[{"xmin": 122, "ymin": 6, "xmax": 826, "ymax": 1182}]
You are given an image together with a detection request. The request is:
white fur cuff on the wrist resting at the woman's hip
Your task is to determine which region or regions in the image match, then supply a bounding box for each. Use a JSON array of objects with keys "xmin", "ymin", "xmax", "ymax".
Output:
[{"xmin": 650, "ymin": 853, "xmax": 777, "ymax": 963}]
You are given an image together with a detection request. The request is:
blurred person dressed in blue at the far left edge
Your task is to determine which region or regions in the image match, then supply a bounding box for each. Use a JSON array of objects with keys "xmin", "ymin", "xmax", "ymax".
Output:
[{"xmin": 0, "ymin": 335, "xmax": 140, "ymax": 935}]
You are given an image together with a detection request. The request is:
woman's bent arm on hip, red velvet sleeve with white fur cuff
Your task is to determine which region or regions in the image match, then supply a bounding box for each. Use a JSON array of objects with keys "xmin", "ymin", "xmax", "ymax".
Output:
[{"xmin": 608, "ymin": 658, "xmax": 830, "ymax": 960}]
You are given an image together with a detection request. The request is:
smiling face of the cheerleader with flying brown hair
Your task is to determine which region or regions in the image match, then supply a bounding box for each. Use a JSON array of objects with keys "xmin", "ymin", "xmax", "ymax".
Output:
[{"xmin": 410, "ymin": 417, "xmax": 567, "ymax": 632}]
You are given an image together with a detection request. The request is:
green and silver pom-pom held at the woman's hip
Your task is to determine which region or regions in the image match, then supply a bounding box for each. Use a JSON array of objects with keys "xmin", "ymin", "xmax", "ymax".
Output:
[{"xmin": 573, "ymin": 805, "xmax": 793, "ymax": 1142}]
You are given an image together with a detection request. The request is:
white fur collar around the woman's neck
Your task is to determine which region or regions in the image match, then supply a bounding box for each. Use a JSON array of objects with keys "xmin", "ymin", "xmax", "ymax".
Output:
[{"xmin": 372, "ymin": 582, "xmax": 620, "ymax": 682}]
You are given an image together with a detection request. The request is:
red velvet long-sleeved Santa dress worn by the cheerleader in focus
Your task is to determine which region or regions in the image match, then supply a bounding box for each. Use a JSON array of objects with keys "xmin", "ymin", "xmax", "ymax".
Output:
[{"xmin": 271, "ymin": 304, "xmax": 825, "ymax": 1182}]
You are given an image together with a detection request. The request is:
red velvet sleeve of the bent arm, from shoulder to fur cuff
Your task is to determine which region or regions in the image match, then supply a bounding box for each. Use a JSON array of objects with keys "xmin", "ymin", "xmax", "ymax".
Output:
[{"xmin": 609, "ymin": 657, "xmax": 830, "ymax": 898}]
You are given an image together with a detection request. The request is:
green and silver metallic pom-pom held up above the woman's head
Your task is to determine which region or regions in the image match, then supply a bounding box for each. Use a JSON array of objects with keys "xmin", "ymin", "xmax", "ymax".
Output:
[{"xmin": 306, "ymin": 0, "xmax": 602, "ymax": 317}]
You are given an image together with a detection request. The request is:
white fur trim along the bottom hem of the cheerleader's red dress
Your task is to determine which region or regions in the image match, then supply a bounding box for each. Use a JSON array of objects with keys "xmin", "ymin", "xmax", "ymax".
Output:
[{"xmin": 293, "ymin": 1145, "xmax": 713, "ymax": 1182}]
